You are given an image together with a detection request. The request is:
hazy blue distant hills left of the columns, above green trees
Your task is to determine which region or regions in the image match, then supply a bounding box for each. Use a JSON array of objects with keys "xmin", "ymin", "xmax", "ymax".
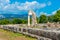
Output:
[{"xmin": 0, "ymin": 14, "xmax": 28, "ymax": 19}]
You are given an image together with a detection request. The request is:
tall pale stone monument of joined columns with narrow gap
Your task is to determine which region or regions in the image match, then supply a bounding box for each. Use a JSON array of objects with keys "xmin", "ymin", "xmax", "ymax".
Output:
[{"xmin": 28, "ymin": 10, "xmax": 37, "ymax": 27}]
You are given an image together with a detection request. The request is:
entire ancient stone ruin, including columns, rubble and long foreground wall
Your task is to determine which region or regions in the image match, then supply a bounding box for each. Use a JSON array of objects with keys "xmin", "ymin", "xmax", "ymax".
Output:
[{"xmin": 0, "ymin": 10, "xmax": 60, "ymax": 40}]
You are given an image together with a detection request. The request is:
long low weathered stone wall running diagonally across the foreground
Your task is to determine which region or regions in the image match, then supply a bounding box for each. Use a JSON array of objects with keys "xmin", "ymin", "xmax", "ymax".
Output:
[{"xmin": 0, "ymin": 25, "xmax": 60, "ymax": 40}]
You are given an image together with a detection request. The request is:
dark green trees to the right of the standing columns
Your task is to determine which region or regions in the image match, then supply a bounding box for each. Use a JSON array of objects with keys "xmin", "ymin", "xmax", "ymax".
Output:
[{"xmin": 39, "ymin": 10, "xmax": 60, "ymax": 23}]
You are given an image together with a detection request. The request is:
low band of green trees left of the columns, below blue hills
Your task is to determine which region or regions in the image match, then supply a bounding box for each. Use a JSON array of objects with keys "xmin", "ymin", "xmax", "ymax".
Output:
[{"xmin": 0, "ymin": 18, "xmax": 27, "ymax": 24}]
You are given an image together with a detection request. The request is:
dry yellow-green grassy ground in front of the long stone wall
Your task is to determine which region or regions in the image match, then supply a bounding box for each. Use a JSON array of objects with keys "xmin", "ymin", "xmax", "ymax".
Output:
[{"xmin": 0, "ymin": 29, "xmax": 36, "ymax": 40}]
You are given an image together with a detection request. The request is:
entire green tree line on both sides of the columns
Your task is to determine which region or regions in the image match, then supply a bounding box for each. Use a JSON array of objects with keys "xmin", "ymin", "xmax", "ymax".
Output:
[{"xmin": 0, "ymin": 10, "xmax": 60, "ymax": 24}]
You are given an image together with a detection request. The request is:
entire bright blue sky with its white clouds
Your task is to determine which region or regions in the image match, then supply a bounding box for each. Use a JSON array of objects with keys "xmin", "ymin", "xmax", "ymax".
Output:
[{"xmin": 0, "ymin": 0, "xmax": 60, "ymax": 16}]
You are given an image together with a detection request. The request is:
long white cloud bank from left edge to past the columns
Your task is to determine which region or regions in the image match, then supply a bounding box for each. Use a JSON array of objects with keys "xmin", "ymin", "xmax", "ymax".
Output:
[{"xmin": 0, "ymin": 0, "xmax": 51, "ymax": 13}]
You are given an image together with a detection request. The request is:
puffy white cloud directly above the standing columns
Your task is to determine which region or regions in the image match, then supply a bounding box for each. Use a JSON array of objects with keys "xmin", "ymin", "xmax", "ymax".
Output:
[{"xmin": 17, "ymin": 1, "xmax": 46, "ymax": 10}]
